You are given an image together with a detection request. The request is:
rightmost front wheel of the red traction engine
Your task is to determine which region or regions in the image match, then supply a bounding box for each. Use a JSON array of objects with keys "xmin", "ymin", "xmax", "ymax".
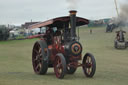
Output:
[{"xmin": 82, "ymin": 53, "xmax": 96, "ymax": 77}]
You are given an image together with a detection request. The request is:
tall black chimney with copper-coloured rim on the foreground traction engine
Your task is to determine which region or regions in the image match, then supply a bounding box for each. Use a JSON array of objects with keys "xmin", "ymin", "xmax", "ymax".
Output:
[{"xmin": 69, "ymin": 10, "xmax": 77, "ymax": 39}]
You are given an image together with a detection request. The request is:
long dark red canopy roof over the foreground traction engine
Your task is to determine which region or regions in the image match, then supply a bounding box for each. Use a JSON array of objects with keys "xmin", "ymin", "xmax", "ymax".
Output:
[{"xmin": 28, "ymin": 16, "xmax": 89, "ymax": 29}]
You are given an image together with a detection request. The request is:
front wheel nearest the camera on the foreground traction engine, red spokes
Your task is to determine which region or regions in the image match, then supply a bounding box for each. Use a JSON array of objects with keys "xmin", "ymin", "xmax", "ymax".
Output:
[{"xmin": 54, "ymin": 53, "xmax": 66, "ymax": 79}]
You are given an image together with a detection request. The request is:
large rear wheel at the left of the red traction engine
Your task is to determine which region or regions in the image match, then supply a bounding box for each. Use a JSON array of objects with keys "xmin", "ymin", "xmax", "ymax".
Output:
[{"xmin": 32, "ymin": 41, "xmax": 48, "ymax": 75}]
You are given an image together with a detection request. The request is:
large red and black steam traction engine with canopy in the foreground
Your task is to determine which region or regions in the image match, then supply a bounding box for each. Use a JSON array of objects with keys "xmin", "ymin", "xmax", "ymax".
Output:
[{"xmin": 29, "ymin": 10, "xmax": 96, "ymax": 79}]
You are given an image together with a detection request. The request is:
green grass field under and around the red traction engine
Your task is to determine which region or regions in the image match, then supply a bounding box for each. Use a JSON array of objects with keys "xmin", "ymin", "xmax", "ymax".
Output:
[{"xmin": 0, "ymin": 27, "xmax": 128, "ymax": 85}]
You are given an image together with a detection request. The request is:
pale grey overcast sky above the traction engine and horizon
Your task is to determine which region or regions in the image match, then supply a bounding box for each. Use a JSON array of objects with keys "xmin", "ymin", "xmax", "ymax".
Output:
[{"xmin": 0, "ymin": 0, "xmax": 128, "ymax": 25}]
